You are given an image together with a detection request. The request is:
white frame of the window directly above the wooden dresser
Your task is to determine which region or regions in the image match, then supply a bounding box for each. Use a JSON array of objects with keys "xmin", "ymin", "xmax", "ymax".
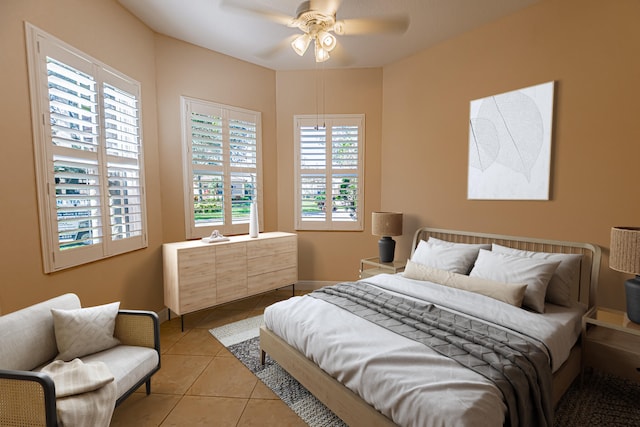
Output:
[{"xmin": 180, "ymin": 95, "xmax": 263, "ymax": 239}]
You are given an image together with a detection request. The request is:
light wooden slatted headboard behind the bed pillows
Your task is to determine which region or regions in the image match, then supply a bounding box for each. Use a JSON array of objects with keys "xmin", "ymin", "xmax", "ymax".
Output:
[{"xmin": 411, "ymin": 227, "xmax": 602, "ymax": 307}]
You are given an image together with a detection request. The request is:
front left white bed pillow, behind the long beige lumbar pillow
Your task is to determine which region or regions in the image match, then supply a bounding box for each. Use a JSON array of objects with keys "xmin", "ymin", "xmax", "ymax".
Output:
[{"xmin": 411, "ymin": 240, "xmax": 488, "ymax": 274}]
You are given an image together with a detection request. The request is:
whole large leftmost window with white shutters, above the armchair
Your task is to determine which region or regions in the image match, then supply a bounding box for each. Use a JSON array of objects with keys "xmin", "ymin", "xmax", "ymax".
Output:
[{"xmin": 26, "ymin": 24, "xmax": 147, "ymax": 273}]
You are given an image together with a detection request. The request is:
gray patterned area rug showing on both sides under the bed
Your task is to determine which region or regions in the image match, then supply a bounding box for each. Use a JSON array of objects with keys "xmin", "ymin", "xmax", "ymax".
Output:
[{"xmin": 211, "ymin": 316, "xmax": 640, "ymax": 427}]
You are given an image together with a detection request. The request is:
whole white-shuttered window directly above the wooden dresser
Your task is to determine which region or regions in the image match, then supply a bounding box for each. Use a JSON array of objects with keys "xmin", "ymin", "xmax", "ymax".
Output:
[{"xmin": 181, "ymin": 97, "xmax": 262, "ymax": 239}]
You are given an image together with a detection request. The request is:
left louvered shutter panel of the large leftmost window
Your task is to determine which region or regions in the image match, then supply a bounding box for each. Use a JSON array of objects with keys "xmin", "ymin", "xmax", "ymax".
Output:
[{"xmin": 45, "ymin": 53, "xmax": 103, "ymax": 252}]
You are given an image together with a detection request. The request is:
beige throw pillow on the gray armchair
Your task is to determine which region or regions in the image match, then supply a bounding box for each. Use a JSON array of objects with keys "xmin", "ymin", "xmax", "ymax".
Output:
[{"xmin": 51, "ymin": 302, "xmax": 120, "ymax": 362}]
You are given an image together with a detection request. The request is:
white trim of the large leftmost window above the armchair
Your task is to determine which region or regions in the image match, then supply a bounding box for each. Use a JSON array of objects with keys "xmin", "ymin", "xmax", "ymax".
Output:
[{"xmin": 25, "ymin": 22, "xmax": 148, "ymax": 273}]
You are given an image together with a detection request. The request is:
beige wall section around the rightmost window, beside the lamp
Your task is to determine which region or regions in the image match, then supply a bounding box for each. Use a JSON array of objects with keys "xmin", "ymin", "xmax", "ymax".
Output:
[{"xmin": 276, "ymin": 68, "xmax": 382, "ymax": 281}]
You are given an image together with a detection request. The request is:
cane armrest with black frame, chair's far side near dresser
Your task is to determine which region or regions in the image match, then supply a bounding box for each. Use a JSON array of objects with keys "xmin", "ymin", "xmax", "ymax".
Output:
[{"xmin": 113, "ymin": 310, "xmax": 160, "ymax": 354}]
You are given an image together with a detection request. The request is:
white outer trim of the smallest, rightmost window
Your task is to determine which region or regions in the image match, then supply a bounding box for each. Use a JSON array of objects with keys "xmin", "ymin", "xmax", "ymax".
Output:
[{"xmin": 294, "ymin": 114, "xmax": 365, "ymax": 231}]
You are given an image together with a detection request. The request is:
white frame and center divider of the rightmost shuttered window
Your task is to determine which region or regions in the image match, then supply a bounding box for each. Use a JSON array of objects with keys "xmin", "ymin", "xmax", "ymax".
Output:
[{"xmin": 293, "ymin": 114, "xmax": 365, "ymax": 231}]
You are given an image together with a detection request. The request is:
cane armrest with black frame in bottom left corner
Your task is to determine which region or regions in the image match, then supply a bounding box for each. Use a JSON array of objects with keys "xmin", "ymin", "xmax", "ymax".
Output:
[{"xmin": 0, "ymin": 369, "xmax": 58, "ymax": 427}]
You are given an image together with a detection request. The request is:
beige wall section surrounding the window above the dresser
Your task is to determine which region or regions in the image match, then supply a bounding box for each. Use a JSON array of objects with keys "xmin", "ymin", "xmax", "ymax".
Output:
[{"xmin": 156, "ymin": 35, "xmax": 277, "ymax": 242}]
